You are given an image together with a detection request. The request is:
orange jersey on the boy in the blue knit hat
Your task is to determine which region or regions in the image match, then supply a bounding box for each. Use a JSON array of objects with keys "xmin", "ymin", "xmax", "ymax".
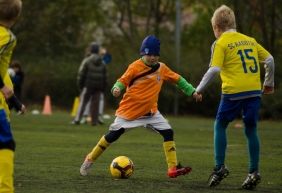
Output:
[{"xmin": 116, "ymin": 59, "xmax": 180, "ymax": 120}]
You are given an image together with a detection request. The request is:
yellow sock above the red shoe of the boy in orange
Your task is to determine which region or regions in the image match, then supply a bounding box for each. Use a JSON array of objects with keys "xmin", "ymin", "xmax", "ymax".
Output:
[{"xmin": 163, "ymin": 141, "xmax": 177, "ymax": 168}]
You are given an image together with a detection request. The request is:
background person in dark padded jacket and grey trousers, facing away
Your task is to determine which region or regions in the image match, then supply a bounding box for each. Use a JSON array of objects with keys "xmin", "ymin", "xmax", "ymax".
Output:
[{"xmin": 72, "ymin": 42, "xmax": 107, "ymax": 125}]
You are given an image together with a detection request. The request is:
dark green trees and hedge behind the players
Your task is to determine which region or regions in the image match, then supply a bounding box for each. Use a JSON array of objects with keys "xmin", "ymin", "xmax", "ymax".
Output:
[{"xmin": 10, "ymin": 0, "xmax": 282, "ymax": 118}]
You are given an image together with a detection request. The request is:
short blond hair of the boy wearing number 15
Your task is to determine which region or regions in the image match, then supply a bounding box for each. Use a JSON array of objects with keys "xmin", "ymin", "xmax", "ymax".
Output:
[{"xmin": 211, "ymin": 5, "xmax": 236, "ymax": 31}]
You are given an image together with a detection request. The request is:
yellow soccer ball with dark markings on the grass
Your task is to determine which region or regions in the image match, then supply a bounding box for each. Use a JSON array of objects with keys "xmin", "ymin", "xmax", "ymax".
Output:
[{"xmin": 110, "ymin": 156, "xmax": 134, "ymax": 179}]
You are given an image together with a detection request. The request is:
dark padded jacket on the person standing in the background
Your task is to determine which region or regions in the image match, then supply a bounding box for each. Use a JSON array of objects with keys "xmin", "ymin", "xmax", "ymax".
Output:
[{"xmin": 77, "ymin": 54, "xmax": 107, "ymax": 91}]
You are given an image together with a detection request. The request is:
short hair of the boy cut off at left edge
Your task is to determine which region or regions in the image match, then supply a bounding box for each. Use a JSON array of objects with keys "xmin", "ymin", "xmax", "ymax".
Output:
[{"xmin": 0, "ymin": 0, "xmax": 22, "ymax": 21}]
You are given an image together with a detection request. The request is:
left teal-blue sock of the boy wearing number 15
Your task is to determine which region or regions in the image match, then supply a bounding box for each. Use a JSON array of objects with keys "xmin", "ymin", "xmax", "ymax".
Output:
[{"xmin": 214, "ymin": 120, "xmax": 228, "ymax": 169}]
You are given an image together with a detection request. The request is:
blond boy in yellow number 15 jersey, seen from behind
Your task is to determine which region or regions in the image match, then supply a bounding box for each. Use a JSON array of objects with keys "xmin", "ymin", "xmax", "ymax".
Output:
[{"xmin": 196, "ymin": 5, "xmax": 274, "ymax": 189}]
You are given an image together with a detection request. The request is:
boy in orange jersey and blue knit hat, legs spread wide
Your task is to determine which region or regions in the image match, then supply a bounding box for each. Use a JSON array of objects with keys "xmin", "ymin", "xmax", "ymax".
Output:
[{"xmin": 80, "ymin": 35, "xmax": 202, "ymax": 178}]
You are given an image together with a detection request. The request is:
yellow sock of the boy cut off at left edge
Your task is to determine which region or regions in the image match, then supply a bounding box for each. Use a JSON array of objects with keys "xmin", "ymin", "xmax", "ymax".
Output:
[{"xmin": 0, "ymin": 149, "xmax": 14, "ymax": 193}]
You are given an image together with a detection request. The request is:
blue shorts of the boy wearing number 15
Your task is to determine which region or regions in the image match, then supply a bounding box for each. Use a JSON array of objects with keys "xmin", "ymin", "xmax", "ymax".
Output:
[{"xmin": 216, "ymin": 97, "xmax": 261, "ymax": 124}]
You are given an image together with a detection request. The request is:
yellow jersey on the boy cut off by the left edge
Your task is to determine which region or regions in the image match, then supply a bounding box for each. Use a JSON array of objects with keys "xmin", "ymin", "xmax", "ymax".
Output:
[{"xmin": 0, "ymin": 25, "xmax": 16, "ymax": 111}]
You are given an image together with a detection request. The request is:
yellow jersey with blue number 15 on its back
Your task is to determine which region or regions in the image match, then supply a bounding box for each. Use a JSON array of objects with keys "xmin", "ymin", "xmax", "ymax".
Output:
[{"xmin": 210, "ymin": 31, "xmax": 270, "ymax": 94}]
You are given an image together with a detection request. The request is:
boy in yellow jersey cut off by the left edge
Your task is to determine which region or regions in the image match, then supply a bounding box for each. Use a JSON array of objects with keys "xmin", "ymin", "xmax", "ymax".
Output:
[{"xmin": 0, "ymin": 0, "xmax": 22, "ymax": 193}]
